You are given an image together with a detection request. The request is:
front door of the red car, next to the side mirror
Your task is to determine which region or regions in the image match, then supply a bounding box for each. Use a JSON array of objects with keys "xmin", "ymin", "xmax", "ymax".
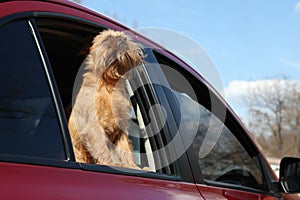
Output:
[{"xmin": 148, "ymin": 50, "xmax": 281, "ymax": 199}]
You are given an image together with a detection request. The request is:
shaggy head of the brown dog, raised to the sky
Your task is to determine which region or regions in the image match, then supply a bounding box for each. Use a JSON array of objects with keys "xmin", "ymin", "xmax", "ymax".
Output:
[{"xmin": 88, "ymin": 30, "xmax": 144, "ymax": 82}]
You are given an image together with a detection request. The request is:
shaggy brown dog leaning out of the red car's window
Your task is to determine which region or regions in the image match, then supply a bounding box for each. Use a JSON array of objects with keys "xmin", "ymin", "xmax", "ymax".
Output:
[{"xmin": 69, "ymin": 30, "xmax": 143, "ymax": 169}]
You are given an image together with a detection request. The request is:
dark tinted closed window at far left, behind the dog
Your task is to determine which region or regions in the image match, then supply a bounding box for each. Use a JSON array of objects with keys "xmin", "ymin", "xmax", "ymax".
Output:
[{"xmin": 0, "ymin": 20, "xmax": 66, "ymax": 160}]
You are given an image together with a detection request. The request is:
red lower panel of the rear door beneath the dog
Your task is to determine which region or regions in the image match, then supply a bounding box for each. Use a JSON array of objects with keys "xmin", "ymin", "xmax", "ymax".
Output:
[{"xmin": 0, "ymin": 163, "xmax": 200, "ymax": 200}]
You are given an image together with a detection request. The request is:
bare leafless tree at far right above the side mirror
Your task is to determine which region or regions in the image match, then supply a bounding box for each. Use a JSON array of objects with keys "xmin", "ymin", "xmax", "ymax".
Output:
[{"xmin": 245, "ymin": 79, "xmax": 300, "ymax": 157}]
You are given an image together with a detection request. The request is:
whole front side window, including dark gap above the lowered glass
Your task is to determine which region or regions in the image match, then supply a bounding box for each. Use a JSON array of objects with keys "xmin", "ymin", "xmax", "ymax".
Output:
[{"xmin": 156, "ymin": 53, "xmax": 267, "ymax": 190}]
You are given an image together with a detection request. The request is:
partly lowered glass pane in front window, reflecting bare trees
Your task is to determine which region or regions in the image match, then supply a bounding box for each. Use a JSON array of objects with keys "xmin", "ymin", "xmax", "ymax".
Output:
[{"xmin": 176, "ymin": 93, "xmax": 263, "ymax": 189}]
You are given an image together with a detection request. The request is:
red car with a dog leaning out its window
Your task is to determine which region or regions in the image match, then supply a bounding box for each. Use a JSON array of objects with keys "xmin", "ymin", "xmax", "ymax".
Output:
[{"xmin": 0, "ymin": 0, "xmax": 300, "ymax": 200}]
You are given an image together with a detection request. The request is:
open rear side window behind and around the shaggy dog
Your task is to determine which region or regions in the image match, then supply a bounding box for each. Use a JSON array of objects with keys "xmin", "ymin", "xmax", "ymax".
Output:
[{"xmin": 36, "ymin": 17, "xmax": 176, "ymax": 175}]
